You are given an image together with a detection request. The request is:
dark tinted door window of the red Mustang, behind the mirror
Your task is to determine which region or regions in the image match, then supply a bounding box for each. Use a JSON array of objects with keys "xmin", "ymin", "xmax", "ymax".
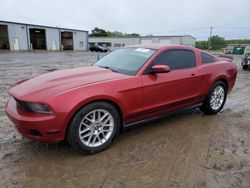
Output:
[{"xmin": 154, "ymin": 50, "xmax": 195, "ymax": 70}]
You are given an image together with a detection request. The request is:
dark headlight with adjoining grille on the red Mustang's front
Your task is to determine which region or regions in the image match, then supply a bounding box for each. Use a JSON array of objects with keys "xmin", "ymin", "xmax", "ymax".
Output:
[{"xmin": 15, "ymin": 98, "xmax": 52, "ymax": 114}]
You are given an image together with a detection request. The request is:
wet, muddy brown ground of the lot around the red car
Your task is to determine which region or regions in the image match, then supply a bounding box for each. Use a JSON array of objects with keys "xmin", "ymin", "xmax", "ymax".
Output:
[{"xmin": 0, "ymin": 52, "xmax": 250, "ymax": 188}]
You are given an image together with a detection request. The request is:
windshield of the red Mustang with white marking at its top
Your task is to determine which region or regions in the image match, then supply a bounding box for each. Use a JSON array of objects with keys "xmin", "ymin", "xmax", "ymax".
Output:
[{"xmin": 94, "ymin": 48, "xmax": 155, "ymax": 75}]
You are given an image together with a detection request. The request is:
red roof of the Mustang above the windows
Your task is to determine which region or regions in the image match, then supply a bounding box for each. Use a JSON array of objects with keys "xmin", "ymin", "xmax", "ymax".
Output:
[{"xmin": 127, "ymin": 44, "xmax": 196, "ymax": 50}]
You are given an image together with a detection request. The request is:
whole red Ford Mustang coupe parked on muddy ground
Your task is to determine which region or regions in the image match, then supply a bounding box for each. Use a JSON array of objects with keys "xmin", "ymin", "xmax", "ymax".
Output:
[{"xmin": 6, "ymin": 45, "xmax": 237, "ymax": 153}]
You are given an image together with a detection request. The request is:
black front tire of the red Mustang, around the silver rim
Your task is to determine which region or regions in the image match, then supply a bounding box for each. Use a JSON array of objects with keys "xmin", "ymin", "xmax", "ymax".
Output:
[{"xmin": 67, "ymin": 102, "xmax": 120, "ymax": 154}]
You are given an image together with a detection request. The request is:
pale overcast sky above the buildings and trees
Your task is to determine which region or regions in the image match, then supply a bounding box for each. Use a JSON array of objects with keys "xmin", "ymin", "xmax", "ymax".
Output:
[{"xmin": 0, "ymin": 0, "xmax": 250, "ymax": 39}]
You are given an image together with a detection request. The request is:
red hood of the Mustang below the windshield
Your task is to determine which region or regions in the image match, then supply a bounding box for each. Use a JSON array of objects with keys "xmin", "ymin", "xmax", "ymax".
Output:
[{"xmin": 9, "ymin": 66, "xmax": 126, "ymax": 102}]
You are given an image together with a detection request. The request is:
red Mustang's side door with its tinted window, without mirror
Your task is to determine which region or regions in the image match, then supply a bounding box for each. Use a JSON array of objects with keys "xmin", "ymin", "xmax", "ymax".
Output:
[{"xmin": 142, "ymin": 49, "xmax": 202, "ymax": 113}]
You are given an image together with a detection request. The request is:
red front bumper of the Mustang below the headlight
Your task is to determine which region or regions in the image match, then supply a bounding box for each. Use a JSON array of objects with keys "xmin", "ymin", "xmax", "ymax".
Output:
[{"xmin": 5, "ymin": 97, "xmax": 65, "ymax": 142}]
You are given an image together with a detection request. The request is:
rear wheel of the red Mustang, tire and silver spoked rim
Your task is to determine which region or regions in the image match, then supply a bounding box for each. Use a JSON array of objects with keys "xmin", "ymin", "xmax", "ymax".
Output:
[{"xmin": 200, "ymin": 81, "xmax": 227, "ymax": 114}]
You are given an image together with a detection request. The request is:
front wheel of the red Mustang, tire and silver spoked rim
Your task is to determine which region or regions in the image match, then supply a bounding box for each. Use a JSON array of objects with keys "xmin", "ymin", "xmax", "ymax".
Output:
[{"xmin": 67, "ymin": 102, "xmax": 120, "ymax": 154}]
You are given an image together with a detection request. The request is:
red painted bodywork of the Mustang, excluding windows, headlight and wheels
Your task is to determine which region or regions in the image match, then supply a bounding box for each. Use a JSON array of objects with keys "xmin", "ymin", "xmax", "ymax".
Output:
[{"xmin": 5, "ymin": 45, "xmax": 237, "ymax": 142}]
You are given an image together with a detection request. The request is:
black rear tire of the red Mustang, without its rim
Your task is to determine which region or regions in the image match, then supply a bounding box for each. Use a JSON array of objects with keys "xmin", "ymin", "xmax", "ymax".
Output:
[{"xmin": 200, "ymin": 81, "xmax": 227, "ymax": 114}]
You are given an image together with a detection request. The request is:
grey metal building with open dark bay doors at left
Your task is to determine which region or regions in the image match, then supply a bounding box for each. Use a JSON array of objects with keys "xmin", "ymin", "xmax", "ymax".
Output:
[{"xmin": 0, "ymin": 21, "xmax": 88, "ymax": 51}]
